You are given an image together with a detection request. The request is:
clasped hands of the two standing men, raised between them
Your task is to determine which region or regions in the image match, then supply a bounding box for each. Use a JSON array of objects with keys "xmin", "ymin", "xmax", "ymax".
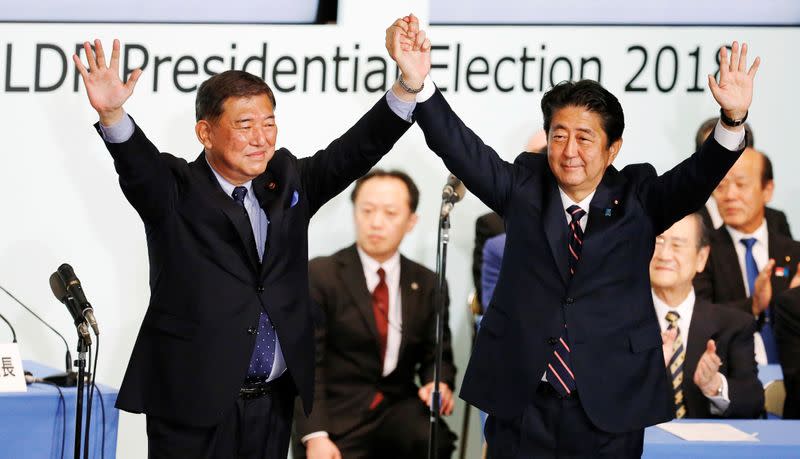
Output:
[{"xmin": 386, "ymin": 14, "xmax": 431, "ymax": 88}]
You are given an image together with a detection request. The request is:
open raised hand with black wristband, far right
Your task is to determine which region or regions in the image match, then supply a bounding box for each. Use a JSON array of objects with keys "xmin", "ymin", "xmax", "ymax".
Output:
[{"xmin": 708, "ymin": 41, "xmax": 761, "ymax": 123}]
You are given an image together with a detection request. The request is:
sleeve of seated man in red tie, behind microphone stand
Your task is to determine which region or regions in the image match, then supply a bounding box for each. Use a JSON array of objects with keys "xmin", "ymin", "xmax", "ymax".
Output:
[{"xmin": 418, "ymin": 282, "xmax": 456, "ymax": 391}]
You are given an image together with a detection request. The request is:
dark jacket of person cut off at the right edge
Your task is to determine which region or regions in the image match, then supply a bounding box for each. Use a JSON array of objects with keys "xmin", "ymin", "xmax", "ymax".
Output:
[{"xmin": 774, "ymin": 288, "xmax": 800, "ymax": 419}]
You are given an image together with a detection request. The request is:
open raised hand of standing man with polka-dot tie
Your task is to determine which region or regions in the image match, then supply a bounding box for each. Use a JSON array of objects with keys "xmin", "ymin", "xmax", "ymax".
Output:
[{"xmin": 72, "ymin": 40, "xmax": 142, "ymax": 126}]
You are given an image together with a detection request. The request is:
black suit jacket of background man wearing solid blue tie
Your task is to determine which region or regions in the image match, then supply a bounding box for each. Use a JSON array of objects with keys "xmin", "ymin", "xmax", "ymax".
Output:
[{"xmin": 694, "ymin": 226, "xmax": 800, "ymax": 323}]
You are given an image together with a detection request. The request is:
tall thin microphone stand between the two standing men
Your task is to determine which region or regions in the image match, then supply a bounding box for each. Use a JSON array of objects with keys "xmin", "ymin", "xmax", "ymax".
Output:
[{"xmin": 428, "ymin": 211, "xmax": 450, "ymax": 459}]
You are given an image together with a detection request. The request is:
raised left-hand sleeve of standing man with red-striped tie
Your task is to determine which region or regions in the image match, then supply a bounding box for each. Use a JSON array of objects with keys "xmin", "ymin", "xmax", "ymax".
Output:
[{"xmin": 414, "ymin": 89, "xmax": 513, "ymax": 215}]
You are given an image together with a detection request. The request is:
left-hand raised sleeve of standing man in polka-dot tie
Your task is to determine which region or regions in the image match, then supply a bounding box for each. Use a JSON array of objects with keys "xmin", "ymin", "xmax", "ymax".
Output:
[{"xmin": 95, "ymin": 123, "xmax": 178, "ymax": 224}]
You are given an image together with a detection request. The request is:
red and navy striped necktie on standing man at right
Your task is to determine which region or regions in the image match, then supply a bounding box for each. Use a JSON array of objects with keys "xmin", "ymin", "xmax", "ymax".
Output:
[{"xmin": 547, "ymin": 205, "xmax": 586, "ymax": 396}]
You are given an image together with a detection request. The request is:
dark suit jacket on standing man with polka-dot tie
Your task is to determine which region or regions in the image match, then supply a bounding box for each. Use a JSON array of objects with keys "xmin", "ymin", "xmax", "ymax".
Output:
[{"xmin": 106, "ymin": 98, "xmax": 409, "ymax": 426}]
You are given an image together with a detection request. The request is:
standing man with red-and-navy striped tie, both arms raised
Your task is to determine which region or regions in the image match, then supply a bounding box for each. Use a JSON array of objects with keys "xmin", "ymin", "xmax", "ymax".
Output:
[{"xmin": 386, "ymin": 15, "xmax": 759, "ymax": 458}]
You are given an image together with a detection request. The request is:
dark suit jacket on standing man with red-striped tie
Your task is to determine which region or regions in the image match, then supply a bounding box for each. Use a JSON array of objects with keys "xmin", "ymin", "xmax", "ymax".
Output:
[{"xmin": 414, "ymin": 91, "xmax": 740, "ymax": 432}]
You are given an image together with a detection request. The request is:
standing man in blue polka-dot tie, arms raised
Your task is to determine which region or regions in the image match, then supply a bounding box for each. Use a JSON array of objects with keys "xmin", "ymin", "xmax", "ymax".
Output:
[{"xmin": 73, "ymin": 40, "xmax": 410, "ymax": 459}]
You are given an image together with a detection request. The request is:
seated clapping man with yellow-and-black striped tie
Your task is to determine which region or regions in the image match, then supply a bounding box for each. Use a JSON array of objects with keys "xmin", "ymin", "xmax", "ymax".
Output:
[{"xmin": 650, "ymin": 213, "xmax": 764, "ymax": 419}]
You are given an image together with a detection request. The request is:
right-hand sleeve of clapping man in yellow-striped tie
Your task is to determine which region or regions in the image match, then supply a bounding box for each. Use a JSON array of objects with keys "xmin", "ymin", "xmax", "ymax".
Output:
[{"xmin": 724, "ymin": 314, "xmax": 764, "ymax": 419}]
